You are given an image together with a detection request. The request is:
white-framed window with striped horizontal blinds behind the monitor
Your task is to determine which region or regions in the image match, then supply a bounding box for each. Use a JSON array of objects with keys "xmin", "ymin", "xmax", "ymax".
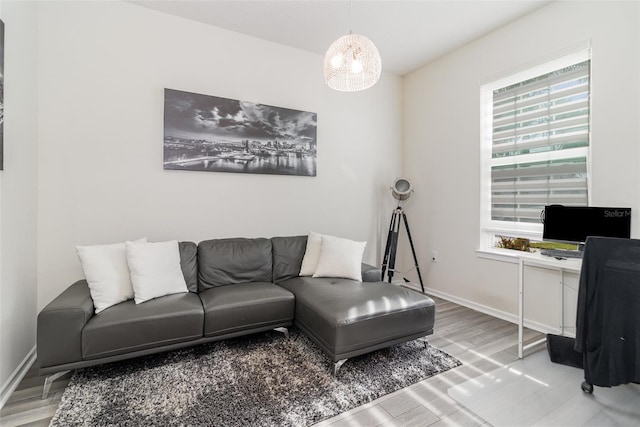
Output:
[{"xmin": 481, "ymin": 50, "xmax": 590, "ymax": 248}]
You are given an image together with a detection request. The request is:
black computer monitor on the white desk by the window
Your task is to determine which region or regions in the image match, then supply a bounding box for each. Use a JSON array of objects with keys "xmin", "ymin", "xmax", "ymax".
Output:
[{"xmin": 542, "ymin": 205, "xmax": 631, "ymax": 243}]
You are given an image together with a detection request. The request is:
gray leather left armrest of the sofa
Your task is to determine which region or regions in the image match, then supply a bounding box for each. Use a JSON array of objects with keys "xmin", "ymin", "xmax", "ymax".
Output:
[{"xmin": 37, "ymin": 280, "xmax": 94, "ymax": 369}]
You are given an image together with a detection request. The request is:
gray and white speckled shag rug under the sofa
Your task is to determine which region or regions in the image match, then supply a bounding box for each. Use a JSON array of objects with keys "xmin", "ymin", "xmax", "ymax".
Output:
[{"xmin": 51, "ymin": 329, "xmax": 460, "ymax": 426}]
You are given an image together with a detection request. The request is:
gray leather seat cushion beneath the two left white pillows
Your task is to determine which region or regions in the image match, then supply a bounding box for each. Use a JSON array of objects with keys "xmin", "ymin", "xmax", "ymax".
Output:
[{"xmin": 82, "ymin": 293, "xmax": 204, "ymax": 360}]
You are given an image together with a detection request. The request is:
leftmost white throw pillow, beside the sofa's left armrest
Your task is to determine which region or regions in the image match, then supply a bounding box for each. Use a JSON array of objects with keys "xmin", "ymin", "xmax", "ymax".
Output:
[{"xmin": 76, "ymin": 237, "xmax": 147, "ymax": 314}]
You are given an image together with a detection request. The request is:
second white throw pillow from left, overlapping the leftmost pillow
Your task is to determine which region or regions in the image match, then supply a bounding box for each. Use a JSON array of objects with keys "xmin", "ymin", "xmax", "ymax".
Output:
[{"xmin": 127, "ymin": 240, "xmax": 189, "ymax": 304}]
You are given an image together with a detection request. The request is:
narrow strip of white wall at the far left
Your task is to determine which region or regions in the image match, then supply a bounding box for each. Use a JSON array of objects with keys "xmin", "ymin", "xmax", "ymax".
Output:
[{"xmin": 0, "ymin": 1, "xmax": 38, "ymax": 406}]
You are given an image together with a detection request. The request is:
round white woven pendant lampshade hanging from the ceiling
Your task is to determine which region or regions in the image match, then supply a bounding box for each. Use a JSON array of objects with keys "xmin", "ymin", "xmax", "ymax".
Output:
[{"xmin": 324, "ymin": 34, "xmax": 382, "ymax": 92}]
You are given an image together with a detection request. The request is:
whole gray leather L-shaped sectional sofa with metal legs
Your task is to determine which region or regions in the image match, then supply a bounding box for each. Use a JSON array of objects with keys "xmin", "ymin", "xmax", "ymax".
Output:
[{"xmin": 37, "ymin": 236, "xmax": 435, "ymax": 397}]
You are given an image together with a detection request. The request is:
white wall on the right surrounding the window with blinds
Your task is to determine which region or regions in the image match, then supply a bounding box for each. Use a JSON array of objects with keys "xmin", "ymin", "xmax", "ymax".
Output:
[{"xmin": 403, "ymin": 1, "xmax": 640, "ymax": 314}]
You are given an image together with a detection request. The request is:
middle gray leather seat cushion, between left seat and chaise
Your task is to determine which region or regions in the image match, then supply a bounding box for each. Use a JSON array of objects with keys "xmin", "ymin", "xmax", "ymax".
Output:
[{"xmin": 200, "ymin": 282, "xmax": 295, "ymax": 337}]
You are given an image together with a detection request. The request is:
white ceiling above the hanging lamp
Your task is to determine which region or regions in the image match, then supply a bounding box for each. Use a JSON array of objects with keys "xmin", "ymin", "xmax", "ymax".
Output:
[{"xmin": 128, "ymin": 0, "xmax": 552, "ymax": 75}]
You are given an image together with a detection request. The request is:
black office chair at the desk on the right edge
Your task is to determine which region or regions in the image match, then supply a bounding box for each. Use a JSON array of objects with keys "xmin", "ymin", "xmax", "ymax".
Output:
[{"xmin": 574, "ymin": 237, "xmax": 640, "ymax": 393}]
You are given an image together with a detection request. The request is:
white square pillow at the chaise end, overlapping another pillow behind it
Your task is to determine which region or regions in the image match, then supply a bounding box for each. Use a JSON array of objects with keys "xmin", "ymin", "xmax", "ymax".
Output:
[{"xmin": 313, "ymin": 236, "xmax": 367, "ymax": 281}]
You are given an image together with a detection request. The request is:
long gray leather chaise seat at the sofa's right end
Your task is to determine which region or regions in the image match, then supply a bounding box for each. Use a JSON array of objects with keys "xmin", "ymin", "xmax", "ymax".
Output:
[{"xmin": 278, "ymin": 277, "xmax": 435, "ymax": 361}]
